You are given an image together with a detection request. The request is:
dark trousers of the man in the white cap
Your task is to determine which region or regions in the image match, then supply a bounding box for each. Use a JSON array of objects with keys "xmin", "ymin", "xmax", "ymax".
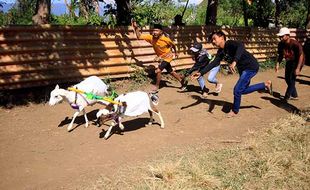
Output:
[{"xmin": 285, "ymin": 61, "xmax": 298, "ymax": 99}]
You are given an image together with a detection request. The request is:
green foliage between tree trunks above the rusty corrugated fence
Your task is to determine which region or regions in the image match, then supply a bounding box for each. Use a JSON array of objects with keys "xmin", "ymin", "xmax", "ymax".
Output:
[{"xmin": 0, "ymin": 0, "xmax": 310, "ymax": 28}]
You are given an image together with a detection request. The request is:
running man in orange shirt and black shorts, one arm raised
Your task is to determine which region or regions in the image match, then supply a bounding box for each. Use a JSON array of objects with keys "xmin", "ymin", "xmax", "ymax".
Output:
[{"xmin": 131, "ymin": 21, "xmax": 187, "ymax": 91}]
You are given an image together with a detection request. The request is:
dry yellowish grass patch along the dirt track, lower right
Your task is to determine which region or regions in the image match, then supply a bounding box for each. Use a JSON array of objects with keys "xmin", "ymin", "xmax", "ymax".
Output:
[{"xmin": 89, "ymin": 109, "xmax": 310, "ymax": 190}]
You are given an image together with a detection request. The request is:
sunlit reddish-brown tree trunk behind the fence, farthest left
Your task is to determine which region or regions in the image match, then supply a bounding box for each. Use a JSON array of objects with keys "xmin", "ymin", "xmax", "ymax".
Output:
[{"xmin": 32, "ymin": 0, "xmax": 51, "ymax": 25}]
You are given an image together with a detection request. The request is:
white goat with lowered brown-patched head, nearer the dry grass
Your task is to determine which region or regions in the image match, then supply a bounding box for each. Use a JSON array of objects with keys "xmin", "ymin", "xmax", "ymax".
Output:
[{"xmin": 96, "ymin": 91, "xmax": 165, "ymax": 139}]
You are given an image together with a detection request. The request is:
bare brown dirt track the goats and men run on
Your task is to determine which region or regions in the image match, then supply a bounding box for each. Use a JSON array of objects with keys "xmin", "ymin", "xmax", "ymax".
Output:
[{"xmin": 0, "ymin": 66, "xmax": 310, "ymax": 190}]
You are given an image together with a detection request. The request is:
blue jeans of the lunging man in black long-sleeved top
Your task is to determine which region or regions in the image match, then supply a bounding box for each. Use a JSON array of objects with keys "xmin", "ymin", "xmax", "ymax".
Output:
[{"xmin": 232, "ymin": 70, "xmax": 265, "ymax": 114}]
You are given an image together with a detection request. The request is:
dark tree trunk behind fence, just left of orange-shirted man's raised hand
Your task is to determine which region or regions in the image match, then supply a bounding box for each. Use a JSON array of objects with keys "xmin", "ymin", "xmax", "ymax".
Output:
[{"xmin": 115, "ymin": 0, "xmax": 131, "ymax": 26}]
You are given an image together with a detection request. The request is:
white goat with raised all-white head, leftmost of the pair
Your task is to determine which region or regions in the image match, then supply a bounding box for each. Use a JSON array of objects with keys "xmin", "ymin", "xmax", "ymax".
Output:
[{"xmin": 49, "ymin": 76, "xmax": 108, "ymax": 131}]
